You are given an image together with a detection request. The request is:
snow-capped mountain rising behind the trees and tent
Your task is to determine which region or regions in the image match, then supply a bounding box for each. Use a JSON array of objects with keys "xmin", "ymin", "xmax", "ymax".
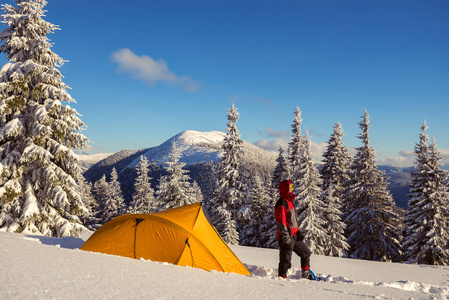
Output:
[{"xmin": 84, "ymin": 130, "xmax": 277, "ymax": 201}]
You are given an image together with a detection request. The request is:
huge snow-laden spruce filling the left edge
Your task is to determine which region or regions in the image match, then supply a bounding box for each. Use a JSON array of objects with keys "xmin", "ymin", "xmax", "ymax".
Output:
[{"xmin": 0, "ymin": 0, "xmax": 88, "ymax": 237}]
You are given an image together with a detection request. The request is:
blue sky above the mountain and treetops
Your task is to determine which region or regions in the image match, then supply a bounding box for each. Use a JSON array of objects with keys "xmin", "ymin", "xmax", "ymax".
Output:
[{"xmin": 1, "ymin": 0, "xmax": 449, "ymax": 165}]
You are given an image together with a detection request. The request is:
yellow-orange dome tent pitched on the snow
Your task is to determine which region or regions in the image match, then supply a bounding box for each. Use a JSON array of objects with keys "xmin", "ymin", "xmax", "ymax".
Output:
[{"xmin": 81, "ymin": 203, "xmax": 251, "ymax": 275}]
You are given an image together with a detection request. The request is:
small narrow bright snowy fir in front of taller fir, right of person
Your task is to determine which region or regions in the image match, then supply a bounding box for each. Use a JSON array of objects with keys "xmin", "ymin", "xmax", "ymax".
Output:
[{"xmin": 323, "ymin": 184, "xmax": 349, "ymax": 257}]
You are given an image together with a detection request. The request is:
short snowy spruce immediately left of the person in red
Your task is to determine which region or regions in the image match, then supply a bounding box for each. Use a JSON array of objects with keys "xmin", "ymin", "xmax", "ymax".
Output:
[{"xmin": 241, "ymin": 174, "xmax": 270, "ymax": 247}]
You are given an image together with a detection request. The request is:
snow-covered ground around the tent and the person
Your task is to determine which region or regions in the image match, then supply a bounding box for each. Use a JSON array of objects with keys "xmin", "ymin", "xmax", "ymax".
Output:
[{"xmin": 0, "ymin": 232, "xmax": 449, "ymax": 300}]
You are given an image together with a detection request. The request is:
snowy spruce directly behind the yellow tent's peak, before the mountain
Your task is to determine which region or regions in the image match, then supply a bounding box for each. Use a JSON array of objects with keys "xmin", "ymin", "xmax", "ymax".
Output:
[{"xmin": 156, "ymin": 141, "xmax": 198, "ymax": 210}]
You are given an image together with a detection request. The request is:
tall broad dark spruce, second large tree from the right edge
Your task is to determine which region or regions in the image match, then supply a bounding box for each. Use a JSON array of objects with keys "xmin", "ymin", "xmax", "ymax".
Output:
[{"xmin": 344, "ymin": 110, "xmax": 401, "ymax": 261}]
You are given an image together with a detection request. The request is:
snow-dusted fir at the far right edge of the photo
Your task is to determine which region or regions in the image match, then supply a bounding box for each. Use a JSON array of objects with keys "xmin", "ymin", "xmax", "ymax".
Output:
[{"xmin": 403, "ymin": 122, "xmax": 449, "ymax": 265}]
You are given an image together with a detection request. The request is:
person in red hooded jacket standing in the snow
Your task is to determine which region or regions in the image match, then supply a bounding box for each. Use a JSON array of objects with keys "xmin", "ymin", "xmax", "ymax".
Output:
[{"xmin": 274, "ymin": 179, "xmax": 311, "ymax": 279}]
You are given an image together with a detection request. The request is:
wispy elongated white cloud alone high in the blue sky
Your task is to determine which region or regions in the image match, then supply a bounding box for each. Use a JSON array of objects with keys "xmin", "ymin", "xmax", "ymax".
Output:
[{"xmin": 111, "ymin": 48, "xmax": 199, "ymax": 92}]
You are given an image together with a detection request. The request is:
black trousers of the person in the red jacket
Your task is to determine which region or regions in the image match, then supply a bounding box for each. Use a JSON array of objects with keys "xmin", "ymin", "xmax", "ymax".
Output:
[{"xmin": 278, "ymin": 235, "xmax": 311, "ymax": 276}]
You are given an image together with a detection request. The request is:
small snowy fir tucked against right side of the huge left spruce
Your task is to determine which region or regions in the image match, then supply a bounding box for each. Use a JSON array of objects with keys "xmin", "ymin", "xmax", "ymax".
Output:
[{"xmin": 78, "ymin": 174, "xmax": 100, "ymax": 230}]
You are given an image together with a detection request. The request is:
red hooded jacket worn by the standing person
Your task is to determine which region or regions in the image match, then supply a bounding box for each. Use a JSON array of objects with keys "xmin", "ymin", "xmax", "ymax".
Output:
[{"xmin": 274, "ymin": 180, "xmax": 298, "ymax": 243}]
